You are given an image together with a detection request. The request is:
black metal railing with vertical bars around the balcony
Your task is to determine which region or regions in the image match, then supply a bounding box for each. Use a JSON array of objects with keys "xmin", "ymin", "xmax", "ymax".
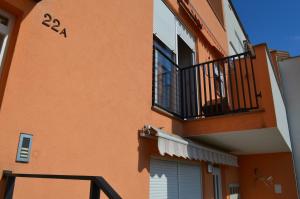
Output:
[{"xmin": 152, "ymin": 46, "xmax": 259, "ymax": 120}]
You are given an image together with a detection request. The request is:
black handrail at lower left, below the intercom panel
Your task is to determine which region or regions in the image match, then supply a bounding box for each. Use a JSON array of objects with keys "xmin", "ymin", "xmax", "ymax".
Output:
[{"xmin": 3, "ymin": 171, "xmax": 121, "ymax": 199}]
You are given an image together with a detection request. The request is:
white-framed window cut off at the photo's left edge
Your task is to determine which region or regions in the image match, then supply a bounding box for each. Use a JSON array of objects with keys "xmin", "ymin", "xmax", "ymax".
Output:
[{"xmin": 0, "ymin": 9, "xmax": 15, "ymax": 71}]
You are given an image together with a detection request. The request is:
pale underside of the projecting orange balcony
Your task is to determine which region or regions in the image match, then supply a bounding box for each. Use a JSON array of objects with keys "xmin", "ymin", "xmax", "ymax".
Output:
[{"xmin": 189, "ymin": 128, "xmax": 291, "ymax": 155}]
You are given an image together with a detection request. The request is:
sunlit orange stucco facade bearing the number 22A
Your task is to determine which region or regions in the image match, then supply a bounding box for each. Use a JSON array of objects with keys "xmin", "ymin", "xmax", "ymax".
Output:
[{"xmin": 0, "ymin": 0, "xmax": 231, "ymax": 199}]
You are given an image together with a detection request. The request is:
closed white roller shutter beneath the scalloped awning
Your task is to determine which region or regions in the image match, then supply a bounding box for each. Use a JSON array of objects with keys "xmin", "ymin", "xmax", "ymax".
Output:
[{"xmin": 150, "ymin": 159, "xmax": 202, "ymax": 199}]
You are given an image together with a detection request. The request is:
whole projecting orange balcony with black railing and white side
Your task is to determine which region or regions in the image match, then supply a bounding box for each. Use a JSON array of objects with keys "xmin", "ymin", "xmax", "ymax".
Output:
[{"xmin": 152, "ymin": 45, "xmax": 291, "ymax": 154}]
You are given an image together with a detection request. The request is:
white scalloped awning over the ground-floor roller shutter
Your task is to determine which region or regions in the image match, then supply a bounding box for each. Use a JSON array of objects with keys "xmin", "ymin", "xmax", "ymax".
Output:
[{"xmin": 141, "ymin": 125, "xmax": 238, "ymax": 167}]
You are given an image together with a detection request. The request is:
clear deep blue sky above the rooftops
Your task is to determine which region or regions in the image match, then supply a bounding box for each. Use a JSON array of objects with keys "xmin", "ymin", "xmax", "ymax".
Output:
[{"xmin": 232, "ymin": 0, "xmax": 300, "ymax": 56}]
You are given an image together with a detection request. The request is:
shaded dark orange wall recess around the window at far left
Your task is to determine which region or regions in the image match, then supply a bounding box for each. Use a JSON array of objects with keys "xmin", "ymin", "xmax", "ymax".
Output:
[{"xmin": 0, "ymin": 0, "xmax": 38, "ymax": 109}]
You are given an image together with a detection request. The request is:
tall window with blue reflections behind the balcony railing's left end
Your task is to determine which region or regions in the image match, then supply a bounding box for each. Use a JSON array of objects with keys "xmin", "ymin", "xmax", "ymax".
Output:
[{"xmin": 153, "ymin": 36, "xmax": 180, "ymax": 115}]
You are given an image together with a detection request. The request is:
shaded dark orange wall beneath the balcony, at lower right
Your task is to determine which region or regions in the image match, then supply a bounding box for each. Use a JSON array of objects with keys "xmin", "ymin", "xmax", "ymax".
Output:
[{"xmin": 239, "ymin": 153, "xmax": 297, "ymax": 199}]
